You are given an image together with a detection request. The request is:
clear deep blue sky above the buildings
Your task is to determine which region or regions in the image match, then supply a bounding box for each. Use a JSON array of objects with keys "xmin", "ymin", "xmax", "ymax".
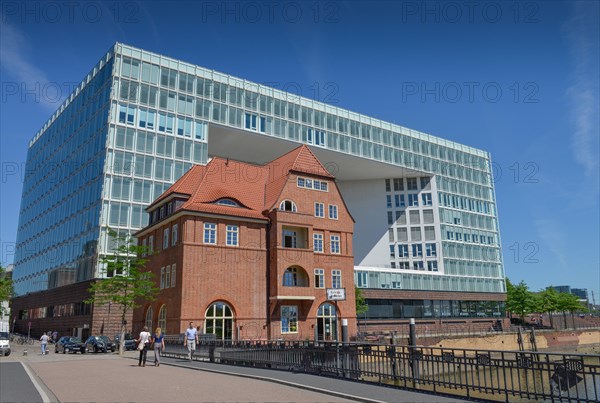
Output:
[{"xmin": 0, "ymin": 1, "xmax": 600, "ymax": 302}]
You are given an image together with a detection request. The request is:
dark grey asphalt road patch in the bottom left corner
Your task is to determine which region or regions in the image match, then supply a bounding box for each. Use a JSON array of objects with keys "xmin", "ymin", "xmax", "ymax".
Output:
[{"xmin": 0, "ymin": 362, "xmax": 42, "ymax": 403}]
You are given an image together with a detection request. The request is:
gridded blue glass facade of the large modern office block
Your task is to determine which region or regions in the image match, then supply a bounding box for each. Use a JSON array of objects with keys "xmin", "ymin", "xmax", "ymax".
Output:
[{"xmin": 15, "ymin": 44, "xmax": 504, "ymax": 294}]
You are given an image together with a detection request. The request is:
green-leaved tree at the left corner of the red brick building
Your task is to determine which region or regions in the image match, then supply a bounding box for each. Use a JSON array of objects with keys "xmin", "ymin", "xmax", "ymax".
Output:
[{"xmin": 86, "ymin": 230, "xmax": 159, "ymax": 354}]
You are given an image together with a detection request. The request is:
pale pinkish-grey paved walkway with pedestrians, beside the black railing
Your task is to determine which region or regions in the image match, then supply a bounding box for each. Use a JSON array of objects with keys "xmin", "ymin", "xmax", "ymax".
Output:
[{"xmin": 0, "ymin": 345, "xmax": 461, "ymax": 402}]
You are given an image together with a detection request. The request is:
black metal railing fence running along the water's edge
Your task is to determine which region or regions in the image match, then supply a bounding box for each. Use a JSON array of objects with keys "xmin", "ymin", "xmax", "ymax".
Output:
[{"xmin": 164, "ymin": 338, "xmax": 600, "ymax": 402}]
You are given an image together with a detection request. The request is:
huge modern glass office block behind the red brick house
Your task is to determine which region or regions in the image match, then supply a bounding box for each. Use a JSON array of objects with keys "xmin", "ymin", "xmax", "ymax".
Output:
[{"xmin": 13, "ymin": 43, "xmax": 505, "ymax": 335}]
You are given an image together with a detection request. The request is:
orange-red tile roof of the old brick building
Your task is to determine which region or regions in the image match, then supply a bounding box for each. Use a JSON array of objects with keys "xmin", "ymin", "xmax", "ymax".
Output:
[{"xmin": 150, "ymin": 145, "xmax": 334, "ymax": 219}]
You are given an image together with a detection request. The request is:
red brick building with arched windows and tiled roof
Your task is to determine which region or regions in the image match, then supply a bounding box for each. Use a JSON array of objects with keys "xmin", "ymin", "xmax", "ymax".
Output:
[{"xmin": 133, "ymin": 146, "xmax": 356, "ymax": 340}]
